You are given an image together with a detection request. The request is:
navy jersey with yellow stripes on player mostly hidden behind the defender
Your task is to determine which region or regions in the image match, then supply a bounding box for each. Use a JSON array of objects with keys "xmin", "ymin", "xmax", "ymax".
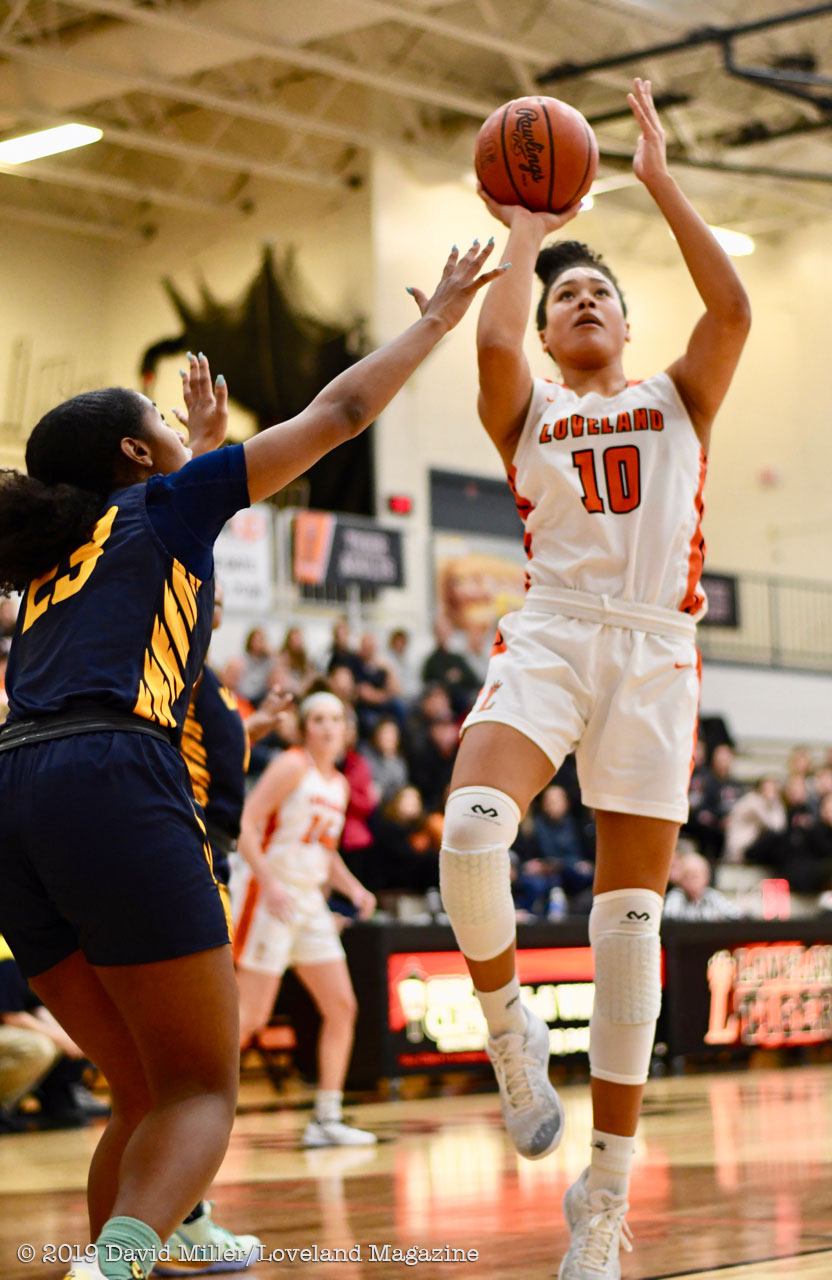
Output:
[{"xmin": 182, "ymin": 666, "xmax": 248, "ymax": 840}]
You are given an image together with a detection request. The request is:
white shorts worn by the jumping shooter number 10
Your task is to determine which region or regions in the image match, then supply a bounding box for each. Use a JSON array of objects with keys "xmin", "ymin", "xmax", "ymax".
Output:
[{"xmin": 462, "ymin": 588, "xmax": 700, "ymax": 822}]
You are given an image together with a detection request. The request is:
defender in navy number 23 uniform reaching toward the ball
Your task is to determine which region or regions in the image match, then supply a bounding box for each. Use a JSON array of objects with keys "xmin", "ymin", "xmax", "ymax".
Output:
[{"xmin": 0, "ymin": 244, "xmax": 502, "ymax": 1280}]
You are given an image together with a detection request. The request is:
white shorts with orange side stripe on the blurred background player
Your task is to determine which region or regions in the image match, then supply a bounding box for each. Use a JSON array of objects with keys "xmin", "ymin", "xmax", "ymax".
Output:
[{"xmin": 229, "ymin": 867, "xmax": 344, "ymax": 975}]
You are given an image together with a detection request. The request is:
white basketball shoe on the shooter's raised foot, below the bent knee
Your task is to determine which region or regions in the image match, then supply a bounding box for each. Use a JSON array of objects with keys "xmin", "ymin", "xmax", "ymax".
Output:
[{"xmin": 486, "ymin": 1009, "xmax": 563, "ymax": 1160}]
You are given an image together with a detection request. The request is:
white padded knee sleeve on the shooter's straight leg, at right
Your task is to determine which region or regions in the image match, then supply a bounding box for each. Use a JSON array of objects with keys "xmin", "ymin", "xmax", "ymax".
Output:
[{"xmin": 589, "ymin": 888, "xmax": 662, "ymax": 1084}]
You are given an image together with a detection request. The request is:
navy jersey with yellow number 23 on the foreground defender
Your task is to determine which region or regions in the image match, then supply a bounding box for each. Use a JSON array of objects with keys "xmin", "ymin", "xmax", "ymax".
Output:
[{"xmin": 6, "ymin": 445, "xmax": 248, "ymax": 737}]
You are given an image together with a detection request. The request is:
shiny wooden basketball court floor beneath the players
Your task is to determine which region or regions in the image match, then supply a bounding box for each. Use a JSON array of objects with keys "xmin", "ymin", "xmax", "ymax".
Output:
[{"xmin": 0, "ymin": 1065, "xmax": 832, "ymax": 1280}]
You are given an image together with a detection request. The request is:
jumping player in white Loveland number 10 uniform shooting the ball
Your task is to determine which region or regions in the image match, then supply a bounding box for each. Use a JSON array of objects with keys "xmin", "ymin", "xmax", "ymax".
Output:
[{"xmin": 442, "ymin": 79, "xmax": 750, "ymax": 1280}]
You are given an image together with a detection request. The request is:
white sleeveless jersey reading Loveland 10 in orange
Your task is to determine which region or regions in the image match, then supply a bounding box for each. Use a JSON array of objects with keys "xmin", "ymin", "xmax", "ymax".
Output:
[{"xmin": 508, "ymin": 372, "xmax": 705, "ymax": 617}]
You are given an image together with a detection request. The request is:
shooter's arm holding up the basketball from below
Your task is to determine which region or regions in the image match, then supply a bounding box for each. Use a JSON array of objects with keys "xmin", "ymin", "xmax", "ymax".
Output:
[{"xmin": 476, "ymin": 187, "xmax": 580, "ymax": 470}]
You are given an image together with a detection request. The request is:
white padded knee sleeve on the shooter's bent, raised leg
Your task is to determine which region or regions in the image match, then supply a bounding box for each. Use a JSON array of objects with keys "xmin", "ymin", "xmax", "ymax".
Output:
[{"xmin": 439, "ymin": 787, "xmax": 520, "ymax": 960}]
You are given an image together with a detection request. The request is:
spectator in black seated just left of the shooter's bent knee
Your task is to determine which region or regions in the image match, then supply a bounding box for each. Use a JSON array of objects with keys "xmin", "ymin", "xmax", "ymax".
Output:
[{"xmin": 372, "ymin": 786, "xmax": 443, "ymax": 892}]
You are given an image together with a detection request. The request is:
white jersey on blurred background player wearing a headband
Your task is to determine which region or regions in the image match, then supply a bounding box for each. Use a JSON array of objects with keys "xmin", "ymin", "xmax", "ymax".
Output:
[{"xmin": 262, "ymin": 748, "xmax": 349, "ymax": 887}]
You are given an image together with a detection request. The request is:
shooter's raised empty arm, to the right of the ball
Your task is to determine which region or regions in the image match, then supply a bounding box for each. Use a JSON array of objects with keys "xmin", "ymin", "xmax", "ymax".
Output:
[{"xmin": 627, "ymin": 79, "xmax": 751, "ymax": 453}]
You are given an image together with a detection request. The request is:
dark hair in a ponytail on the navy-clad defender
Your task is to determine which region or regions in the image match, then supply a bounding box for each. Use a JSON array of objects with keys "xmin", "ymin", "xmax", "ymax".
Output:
[{"xmin": 0, "ymin": 387, "xmax": 145, "ymax": 594}]
